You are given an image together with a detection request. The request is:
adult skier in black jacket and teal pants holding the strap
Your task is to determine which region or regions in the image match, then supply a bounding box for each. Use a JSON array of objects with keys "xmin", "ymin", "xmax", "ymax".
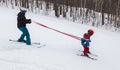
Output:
[{"xmin": 17, "ymin": 9, "xmax": 31, "ymax": 45}]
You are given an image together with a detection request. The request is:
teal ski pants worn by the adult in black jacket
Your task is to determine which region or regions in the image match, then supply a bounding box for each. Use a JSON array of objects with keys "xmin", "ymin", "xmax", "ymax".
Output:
[{"xmin": 18, "ymin": 27, "xmax": 31, "ymax": 45}]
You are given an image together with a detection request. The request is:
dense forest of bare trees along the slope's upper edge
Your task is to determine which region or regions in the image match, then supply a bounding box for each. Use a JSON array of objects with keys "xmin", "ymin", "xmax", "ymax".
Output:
[{"xmin": 0, "ymin": 0, "xmax": 120, "ymax": 30}]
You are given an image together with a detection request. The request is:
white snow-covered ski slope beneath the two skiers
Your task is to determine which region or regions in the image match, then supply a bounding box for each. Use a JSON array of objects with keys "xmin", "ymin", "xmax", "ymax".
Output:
[{"xmin": 0, "ymin": 7, "xmax": 120, "ymax": 70}]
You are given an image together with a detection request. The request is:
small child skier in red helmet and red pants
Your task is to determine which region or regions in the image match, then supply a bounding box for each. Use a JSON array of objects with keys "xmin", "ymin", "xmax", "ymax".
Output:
[{"xmin": 81, "ymin": 29, "xmax": 94, "ymax": 57}]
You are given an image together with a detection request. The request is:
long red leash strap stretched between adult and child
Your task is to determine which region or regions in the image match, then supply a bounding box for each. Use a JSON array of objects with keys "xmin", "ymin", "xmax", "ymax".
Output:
[{"xmin": 33, "ymin": 21, "xmax": 81, "ymax": 40}]
